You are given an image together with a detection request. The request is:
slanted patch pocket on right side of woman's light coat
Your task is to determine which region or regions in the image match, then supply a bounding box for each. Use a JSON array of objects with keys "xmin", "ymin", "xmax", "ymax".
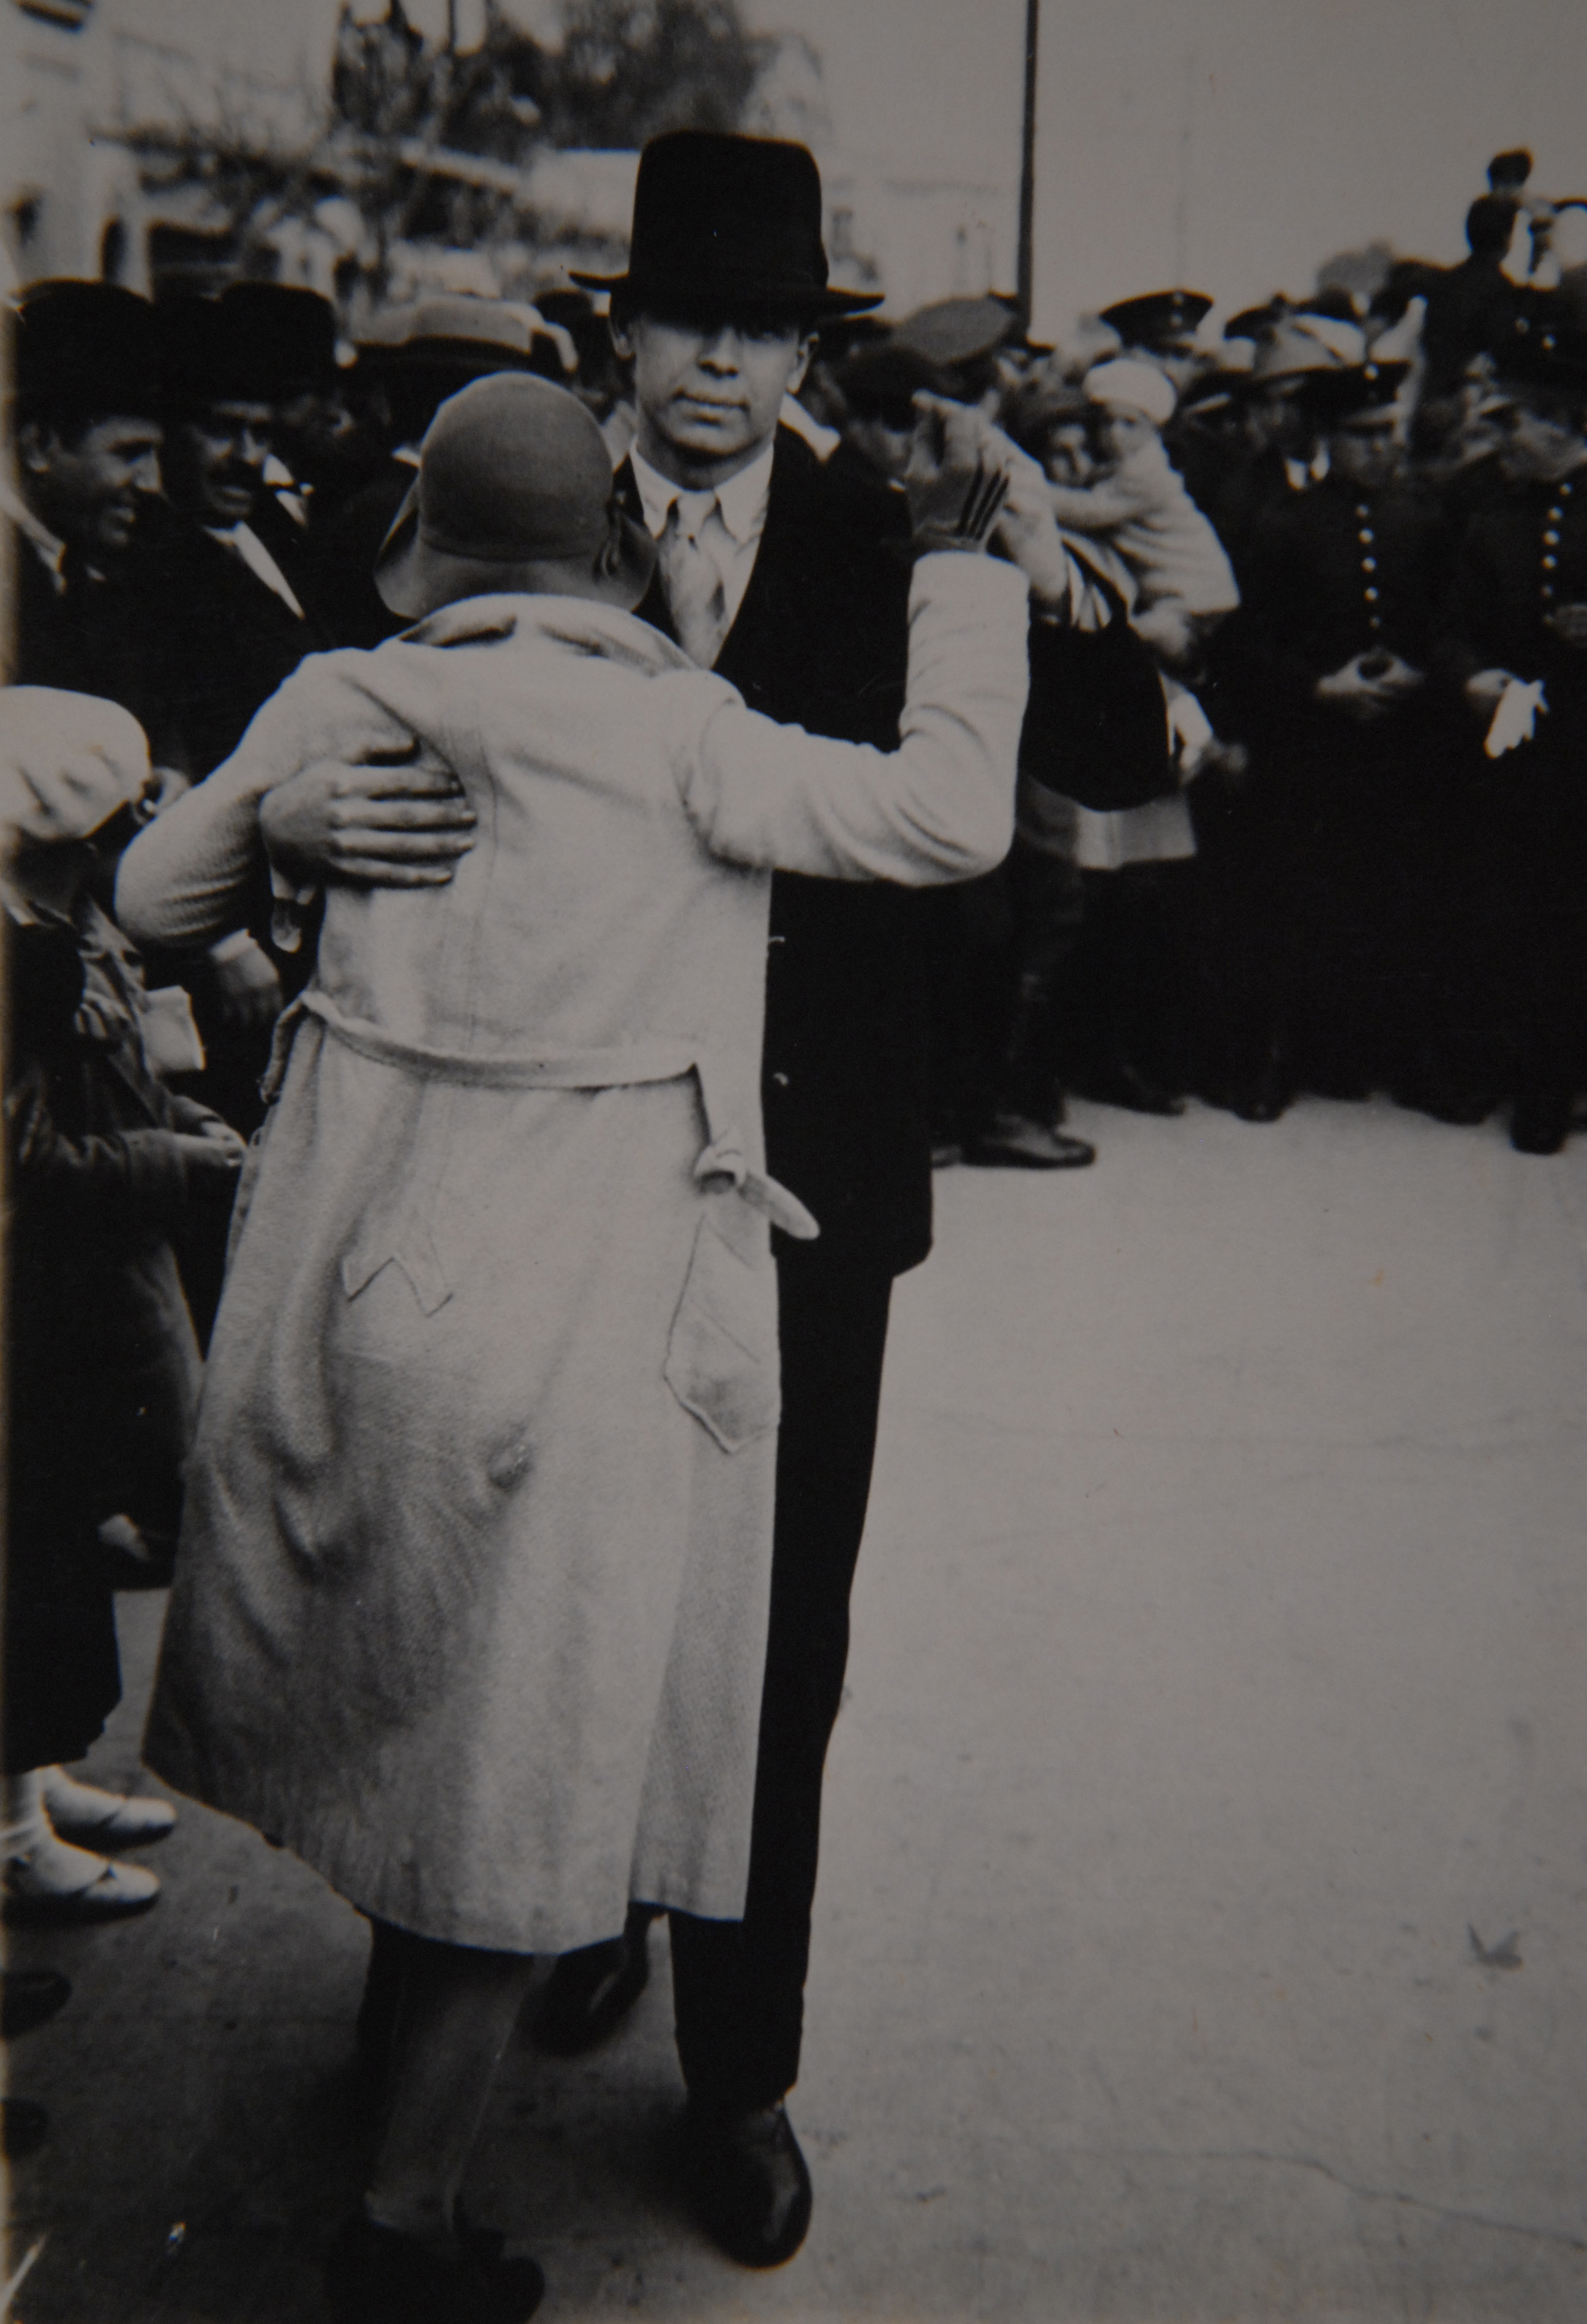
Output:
[{"xmin": 662, "ymin": 1216, "xmax": 781, "ymax": 1453}]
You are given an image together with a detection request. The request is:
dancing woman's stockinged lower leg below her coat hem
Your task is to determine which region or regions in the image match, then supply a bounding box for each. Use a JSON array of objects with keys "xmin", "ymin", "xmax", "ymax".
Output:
[{"xmin": 365, "ymin": 1938, "xmax": 535, "ymax": 2250}]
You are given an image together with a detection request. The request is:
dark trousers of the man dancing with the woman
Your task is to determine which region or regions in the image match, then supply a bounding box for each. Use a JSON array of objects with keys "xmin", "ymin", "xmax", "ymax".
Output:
[{"xmin": 672, "ymin": 1243, "xmax": 892, "ymax": 2113}]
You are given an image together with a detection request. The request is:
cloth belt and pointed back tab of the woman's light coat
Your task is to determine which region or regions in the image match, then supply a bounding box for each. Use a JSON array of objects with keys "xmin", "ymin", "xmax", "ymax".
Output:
[{"xmin": 263, "ymin": 990, "xmax": 820, "ymax": 1313}]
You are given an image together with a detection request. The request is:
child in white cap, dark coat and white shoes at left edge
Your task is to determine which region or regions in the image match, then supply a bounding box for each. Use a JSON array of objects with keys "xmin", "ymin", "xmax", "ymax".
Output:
[{"xmin": 0, "ymin": 686, "xmax": 242, "ymax": 1922}]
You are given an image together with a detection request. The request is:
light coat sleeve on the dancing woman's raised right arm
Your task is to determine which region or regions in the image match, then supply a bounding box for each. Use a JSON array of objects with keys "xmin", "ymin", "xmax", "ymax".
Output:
[{"xmin": 655, "ymin": 553, "xmax": 1029, "ymax": 888}]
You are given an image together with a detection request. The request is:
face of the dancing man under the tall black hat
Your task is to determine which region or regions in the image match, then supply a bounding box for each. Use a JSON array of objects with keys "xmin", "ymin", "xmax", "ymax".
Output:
[{"xmin": 611, "ymin": 314, "xmax": 816, "ymax": 483}]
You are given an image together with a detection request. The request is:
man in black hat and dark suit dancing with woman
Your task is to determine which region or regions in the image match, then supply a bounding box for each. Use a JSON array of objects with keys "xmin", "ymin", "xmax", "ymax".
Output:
[{"xmin": 263, "ymin": 132, "xmax": 1067, "ymax": 2266}]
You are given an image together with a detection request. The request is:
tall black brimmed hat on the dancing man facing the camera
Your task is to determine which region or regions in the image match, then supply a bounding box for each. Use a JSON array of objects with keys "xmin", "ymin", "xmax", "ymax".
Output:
[{"xmin": 574, "ymin": 130, "xmax": 880, "ymax": 321}]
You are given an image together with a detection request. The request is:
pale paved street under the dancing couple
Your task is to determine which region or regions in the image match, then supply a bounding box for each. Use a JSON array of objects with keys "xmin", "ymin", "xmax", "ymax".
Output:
[{"xmin": 12, "ymin": 1102, "xmax": 1587, "ymax": 2324}]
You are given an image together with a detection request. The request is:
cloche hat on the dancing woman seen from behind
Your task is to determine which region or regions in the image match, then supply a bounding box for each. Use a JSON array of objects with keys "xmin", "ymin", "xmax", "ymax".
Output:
[{"xmin": 374, "ymin": 372, "xmax": 655, "ymax": 618}]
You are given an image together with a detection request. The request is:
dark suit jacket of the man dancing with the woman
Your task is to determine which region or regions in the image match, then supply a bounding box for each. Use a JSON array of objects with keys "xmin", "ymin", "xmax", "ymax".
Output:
[{"xmin": 620, "ymin": 427, "xmax": 932, "ymax": 1274}]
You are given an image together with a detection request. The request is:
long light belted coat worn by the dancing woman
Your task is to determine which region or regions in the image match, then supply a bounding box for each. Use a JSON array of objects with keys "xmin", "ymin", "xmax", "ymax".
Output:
[{"xmin": 119, "ymin": 555, "xmax": 1027, "ymax": 1952}]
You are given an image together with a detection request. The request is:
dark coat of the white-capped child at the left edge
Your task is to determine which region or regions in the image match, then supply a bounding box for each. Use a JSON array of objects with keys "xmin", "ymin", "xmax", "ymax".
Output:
[{"xmin": 5, "ymin": 906, "xmax": 202, "ymax": 1773}]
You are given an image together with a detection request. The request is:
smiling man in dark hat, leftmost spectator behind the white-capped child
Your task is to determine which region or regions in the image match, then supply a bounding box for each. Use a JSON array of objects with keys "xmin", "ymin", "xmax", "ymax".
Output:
[{"xmin": 0, "ymin": 281, "xmax": 160, "ymax": 716}]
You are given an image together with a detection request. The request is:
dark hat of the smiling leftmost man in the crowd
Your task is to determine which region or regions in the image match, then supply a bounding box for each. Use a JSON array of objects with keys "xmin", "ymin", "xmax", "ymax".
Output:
[{"xmin": 12, "ymin": 279, "xmax": 160, "ymax": 421}]
